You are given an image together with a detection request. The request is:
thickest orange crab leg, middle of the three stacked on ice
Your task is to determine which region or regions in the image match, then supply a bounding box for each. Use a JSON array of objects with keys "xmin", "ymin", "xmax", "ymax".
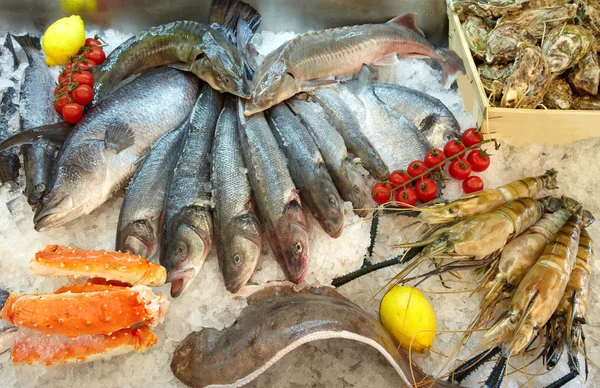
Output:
[{"xmin": 2, "ymin": 284, "xmax": 168, "ymax": 338}]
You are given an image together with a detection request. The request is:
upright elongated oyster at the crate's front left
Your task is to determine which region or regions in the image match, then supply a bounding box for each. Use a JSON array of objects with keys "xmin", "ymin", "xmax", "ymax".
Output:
[{"xmin": 500, "ymin": 43, "xmax": 551, "ymax": 109}]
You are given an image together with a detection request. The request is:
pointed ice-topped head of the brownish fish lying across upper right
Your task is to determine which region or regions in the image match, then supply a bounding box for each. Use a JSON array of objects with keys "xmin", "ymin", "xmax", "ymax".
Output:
[{"xmin": 244, "ymin": 61, "xmax": 299, "ymax": 116}]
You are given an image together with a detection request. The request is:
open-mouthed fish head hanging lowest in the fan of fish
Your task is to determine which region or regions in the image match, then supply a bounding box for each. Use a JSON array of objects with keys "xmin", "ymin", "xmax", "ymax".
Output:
[{"xmin": 161, "ymin": 206, "xmax": 212, "ymax": 298}]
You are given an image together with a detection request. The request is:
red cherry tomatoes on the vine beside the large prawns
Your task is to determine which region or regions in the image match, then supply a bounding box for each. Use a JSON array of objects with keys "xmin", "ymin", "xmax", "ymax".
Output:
[{"xmin": 371, "ymin": 128, "xmax": 490, "ymax": 207}]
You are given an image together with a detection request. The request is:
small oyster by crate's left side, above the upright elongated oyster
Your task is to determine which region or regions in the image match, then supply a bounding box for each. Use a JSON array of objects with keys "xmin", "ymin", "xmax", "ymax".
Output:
[{"xmin": 485, "ymin": 22, "xmax": 536, "ymax": 63}]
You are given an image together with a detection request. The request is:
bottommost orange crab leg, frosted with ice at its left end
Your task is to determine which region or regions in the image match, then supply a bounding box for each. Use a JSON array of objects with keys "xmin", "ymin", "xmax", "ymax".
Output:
[{"xmin": 11, "ymin": 326, "xmax": 158, "ymax": 365}]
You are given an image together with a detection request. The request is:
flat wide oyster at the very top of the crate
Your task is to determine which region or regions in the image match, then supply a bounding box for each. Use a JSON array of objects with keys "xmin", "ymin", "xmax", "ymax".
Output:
[{"xmin": 498, "ymin": 4, "xmax": 577, "ymax": 40}]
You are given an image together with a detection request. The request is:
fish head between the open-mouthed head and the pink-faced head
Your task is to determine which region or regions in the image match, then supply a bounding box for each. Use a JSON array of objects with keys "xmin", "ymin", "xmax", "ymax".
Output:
[{"xmin": 219, "ymin": 213, "xmax": 262, "ymax": 293}]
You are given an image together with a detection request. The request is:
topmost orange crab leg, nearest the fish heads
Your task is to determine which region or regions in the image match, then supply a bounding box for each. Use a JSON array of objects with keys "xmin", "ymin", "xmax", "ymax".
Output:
[{"xmin": 30, "ymin": 245, "xmax": 167, "ymax": 287}]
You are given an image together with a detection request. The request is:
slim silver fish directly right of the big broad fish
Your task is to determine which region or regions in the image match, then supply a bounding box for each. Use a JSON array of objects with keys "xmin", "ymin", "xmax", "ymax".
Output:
[{"xmin": 116, "ymin": 121, "xmax": 187, "ymax": 261}]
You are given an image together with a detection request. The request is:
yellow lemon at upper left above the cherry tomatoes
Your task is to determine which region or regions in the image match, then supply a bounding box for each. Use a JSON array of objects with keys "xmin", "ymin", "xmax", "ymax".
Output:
[{"xmin": 42, "ymin": 15, "xmax": 85, "ymax": 66}]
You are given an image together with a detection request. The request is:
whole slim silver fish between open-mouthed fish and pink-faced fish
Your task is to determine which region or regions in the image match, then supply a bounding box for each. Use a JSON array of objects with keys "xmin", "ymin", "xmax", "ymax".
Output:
[{"xmin": 211, "ymin": 99, "xmax": 262, "ymax": 293}]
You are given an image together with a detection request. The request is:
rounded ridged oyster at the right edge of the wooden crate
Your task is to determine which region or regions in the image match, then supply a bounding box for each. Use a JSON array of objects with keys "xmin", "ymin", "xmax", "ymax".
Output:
[{"xmin": 542, "ymin": 25, "xmax": 595, "ymax": 76}]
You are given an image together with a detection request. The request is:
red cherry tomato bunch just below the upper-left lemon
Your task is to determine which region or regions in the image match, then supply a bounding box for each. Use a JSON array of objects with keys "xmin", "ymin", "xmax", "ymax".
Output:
[{"xmin": 54, "ymin": 37, "xmax": 106, "ymax": 124}]
